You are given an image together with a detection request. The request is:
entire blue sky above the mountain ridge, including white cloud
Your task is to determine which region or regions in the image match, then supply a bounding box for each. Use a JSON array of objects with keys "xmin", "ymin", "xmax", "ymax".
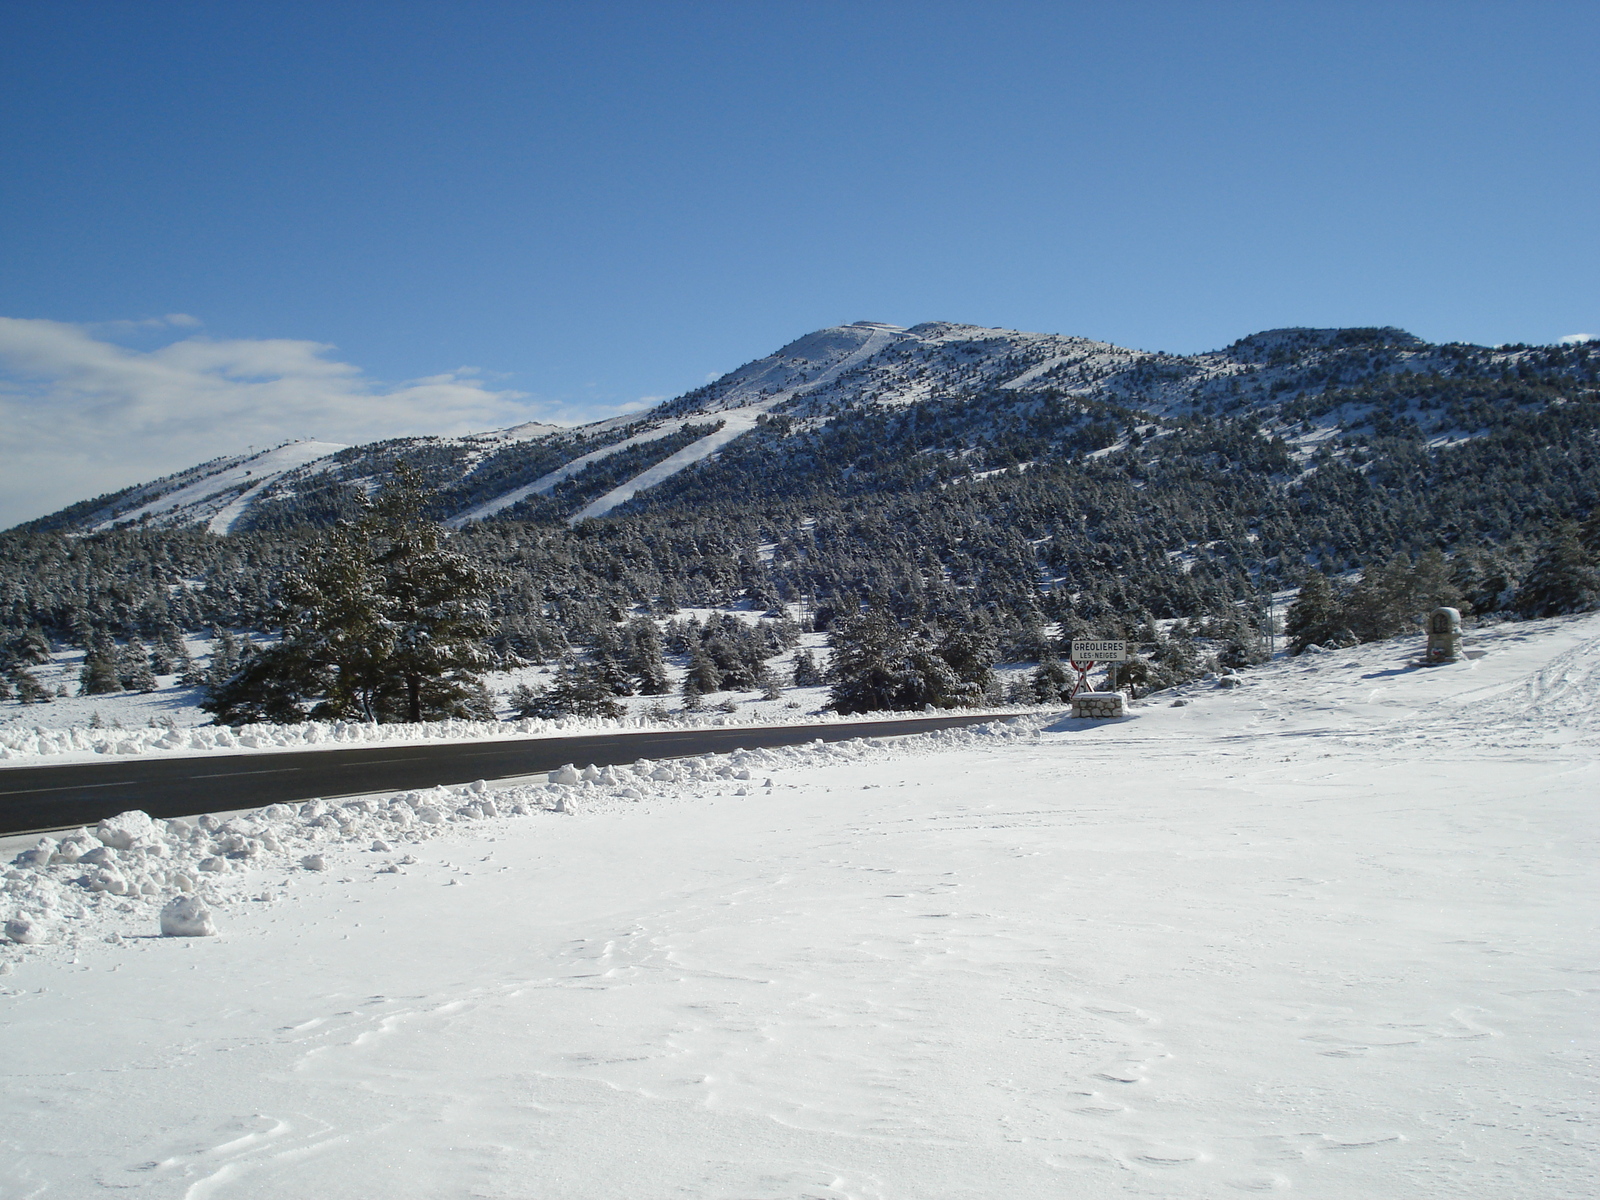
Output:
[{"xmin": 0, "ymin": 0, "xmax": 1600, "ymax": 525}]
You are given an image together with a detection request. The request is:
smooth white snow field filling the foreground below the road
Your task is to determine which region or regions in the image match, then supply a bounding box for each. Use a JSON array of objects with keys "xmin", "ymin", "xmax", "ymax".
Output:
[{"xmin": 0, "ymin": 616, "xmax": 1600, "ymax": 1200}]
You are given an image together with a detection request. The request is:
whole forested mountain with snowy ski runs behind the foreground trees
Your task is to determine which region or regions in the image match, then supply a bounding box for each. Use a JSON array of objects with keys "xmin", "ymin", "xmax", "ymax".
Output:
[{"xmin": 0, "ymin": 322, "xmax": 1600, "ymax": 684}]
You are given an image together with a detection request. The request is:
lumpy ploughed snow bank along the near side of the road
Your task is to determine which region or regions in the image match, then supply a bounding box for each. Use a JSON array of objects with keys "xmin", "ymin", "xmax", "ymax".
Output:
[{"xmin": 0, "ymin": 715, "xmax": 1046, "ymax": 952}]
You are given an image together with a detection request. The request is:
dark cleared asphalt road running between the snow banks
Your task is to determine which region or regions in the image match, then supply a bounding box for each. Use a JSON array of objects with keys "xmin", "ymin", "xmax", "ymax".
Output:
[{"xmin": 0, "ymin": 715, "xmax": 995, "ymax": 835}]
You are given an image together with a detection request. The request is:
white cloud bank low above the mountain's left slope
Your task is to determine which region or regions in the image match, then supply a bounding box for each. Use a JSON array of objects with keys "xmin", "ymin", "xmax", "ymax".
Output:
[{"xmin": 0, "ymin": 314, "xmax": 550, "ymax": 528}]
